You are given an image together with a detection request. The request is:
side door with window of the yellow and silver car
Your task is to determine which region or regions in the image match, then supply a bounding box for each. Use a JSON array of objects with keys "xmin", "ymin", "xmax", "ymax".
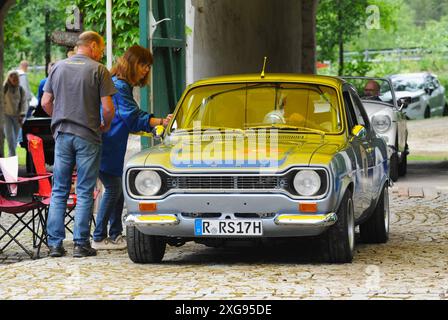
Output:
[{"xmin": 343, "ymin": 87, "xmax": 371, "ymax": 219}]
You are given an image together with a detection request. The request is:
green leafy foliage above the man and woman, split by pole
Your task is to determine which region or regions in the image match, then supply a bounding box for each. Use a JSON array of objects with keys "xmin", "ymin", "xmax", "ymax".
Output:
[{"xmin": 75, "ymin": 0, "xmax": 139, "ymax": 57}]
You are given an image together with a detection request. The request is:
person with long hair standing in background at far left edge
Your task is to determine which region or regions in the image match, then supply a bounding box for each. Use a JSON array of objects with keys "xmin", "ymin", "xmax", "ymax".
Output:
[{"xmin": 3, "ymin": 70, "xmax": 26, "ymax": 157}]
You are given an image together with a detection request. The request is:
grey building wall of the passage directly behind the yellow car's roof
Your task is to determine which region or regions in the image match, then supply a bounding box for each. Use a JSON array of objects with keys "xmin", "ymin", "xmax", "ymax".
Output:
[{"xmin": 186, "ymin": 0, "xmax": 317, "ymax": 83}]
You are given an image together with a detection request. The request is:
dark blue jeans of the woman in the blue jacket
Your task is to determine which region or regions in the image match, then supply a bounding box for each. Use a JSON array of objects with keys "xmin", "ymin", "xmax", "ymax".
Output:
[{"xmin": 93, "ymin": 171, "xmax": 124, "ymax": 242}]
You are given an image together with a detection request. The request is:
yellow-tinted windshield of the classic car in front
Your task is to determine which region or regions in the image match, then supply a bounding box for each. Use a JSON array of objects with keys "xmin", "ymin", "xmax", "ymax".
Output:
[{"xmin": 171, "ymin": 83, "xmax": 342, "ymax": 133}]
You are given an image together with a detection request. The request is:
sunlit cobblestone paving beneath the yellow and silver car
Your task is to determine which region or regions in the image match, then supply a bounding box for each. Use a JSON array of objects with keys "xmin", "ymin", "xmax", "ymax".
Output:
[{"xmin": 0, "ymin": 186, "xmax": 448, "ymax": 299}]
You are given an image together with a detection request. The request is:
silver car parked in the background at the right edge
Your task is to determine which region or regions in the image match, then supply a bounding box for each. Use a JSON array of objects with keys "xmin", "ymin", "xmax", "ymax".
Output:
[{"xmin": 390, "ymin": 72, "xmax": 448, "ymax": 119}]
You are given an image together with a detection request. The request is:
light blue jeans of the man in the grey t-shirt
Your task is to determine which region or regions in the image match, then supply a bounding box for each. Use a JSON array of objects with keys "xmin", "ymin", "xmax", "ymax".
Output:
[{"xmin": 47, "ymin": 133, "xmax": 101, "ymax": 247}]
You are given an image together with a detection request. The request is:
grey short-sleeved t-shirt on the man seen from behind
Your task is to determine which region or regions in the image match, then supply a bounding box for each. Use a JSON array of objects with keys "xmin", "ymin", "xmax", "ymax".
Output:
[{"xmin": 44, "ymin": 54, "xmax": 117, "ymax": 144}]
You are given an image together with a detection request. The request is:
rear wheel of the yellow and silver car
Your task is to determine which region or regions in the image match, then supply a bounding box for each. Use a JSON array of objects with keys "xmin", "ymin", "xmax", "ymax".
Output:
[{"xmin": 359, "ymin": 184, "xmax": 390, "ymax": 243}]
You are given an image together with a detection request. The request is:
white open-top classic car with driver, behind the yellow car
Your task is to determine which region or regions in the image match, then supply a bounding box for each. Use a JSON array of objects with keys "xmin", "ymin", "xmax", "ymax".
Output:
[{"xmin": 343, "ymin": 77, "xmax": 411, "ymax": 181}]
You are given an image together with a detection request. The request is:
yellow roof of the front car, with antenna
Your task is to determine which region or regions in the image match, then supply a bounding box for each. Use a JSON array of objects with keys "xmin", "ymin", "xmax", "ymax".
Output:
[{"xmin": 187, "ymin": 73, "xmax": 345, "ymax": 87}]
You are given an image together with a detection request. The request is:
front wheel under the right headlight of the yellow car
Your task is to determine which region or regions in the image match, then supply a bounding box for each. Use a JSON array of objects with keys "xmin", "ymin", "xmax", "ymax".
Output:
[{"xmin": 321, "ymin": 190, "xmax": 355, "ymax": 263}]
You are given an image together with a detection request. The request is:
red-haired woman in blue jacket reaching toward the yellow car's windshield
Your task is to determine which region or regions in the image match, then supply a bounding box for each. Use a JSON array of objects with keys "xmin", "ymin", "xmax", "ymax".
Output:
[{"xmin": 92, "ymin": 45, "xmax": 172, "ymax": 250}]
